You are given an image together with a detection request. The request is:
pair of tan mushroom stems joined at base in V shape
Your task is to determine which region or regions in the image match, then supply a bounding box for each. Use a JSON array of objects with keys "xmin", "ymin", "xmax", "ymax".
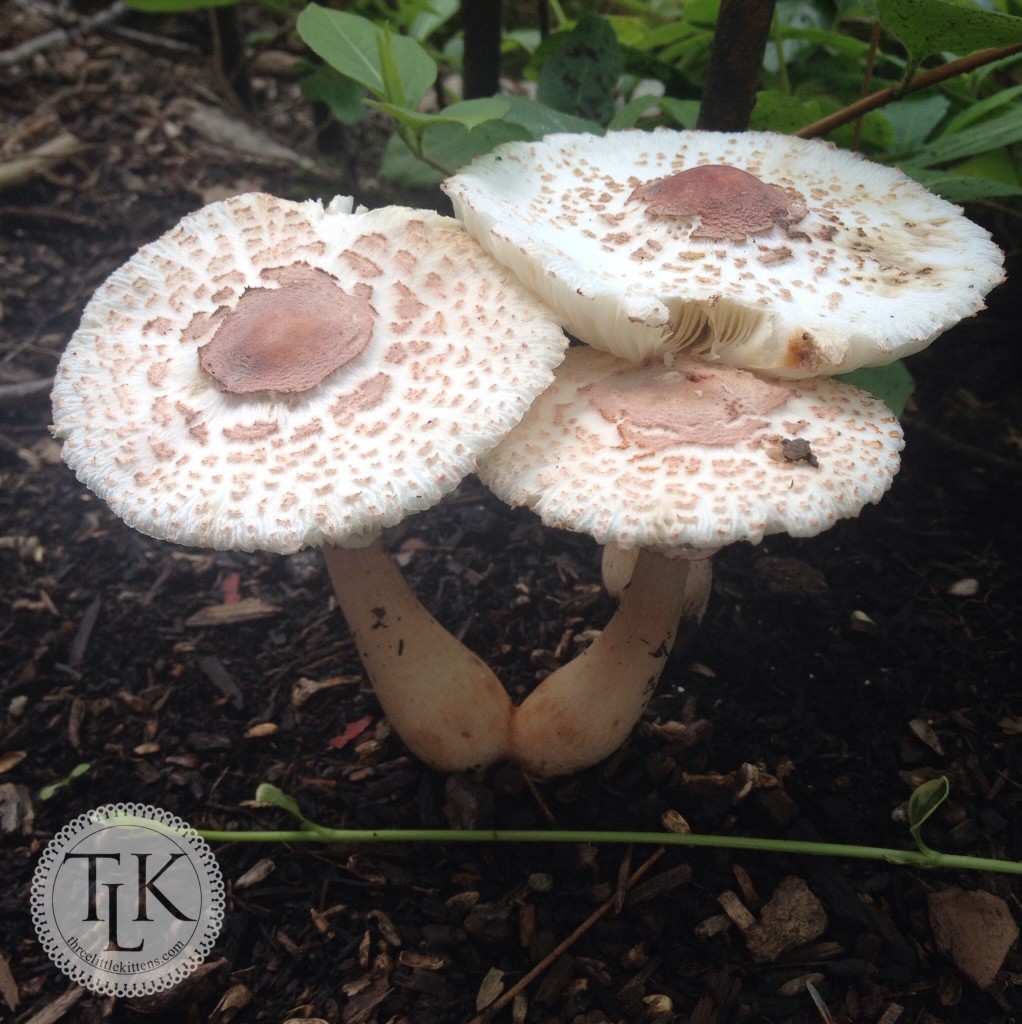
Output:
[{"xmin": 324, "ymin": 540, "xmax": 699, "ymax": 776}]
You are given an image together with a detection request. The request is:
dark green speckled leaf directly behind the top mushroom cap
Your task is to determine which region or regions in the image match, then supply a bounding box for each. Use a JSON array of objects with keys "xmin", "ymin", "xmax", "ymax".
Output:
[{"xmin": 537, "ymin": 14, "xmax": 625, "ymax": 124}]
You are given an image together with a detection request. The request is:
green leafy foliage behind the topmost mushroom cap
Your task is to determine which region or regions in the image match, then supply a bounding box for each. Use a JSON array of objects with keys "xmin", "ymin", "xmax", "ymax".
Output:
[{"xmin": 292, "ymin": 0, "xmax": 1022, "ymax": 209}]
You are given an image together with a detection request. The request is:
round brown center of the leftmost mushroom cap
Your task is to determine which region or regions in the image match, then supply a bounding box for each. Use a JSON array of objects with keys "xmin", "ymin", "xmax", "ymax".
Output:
[{"xmin": 199, "ymin": 263, "xmax": 376, "ymax": 394}]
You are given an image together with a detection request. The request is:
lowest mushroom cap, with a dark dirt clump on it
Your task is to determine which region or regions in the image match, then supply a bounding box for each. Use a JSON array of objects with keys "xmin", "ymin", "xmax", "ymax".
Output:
[{"xmin": 479, "ymin": 346, "xmax": 903, "ymax": 555}]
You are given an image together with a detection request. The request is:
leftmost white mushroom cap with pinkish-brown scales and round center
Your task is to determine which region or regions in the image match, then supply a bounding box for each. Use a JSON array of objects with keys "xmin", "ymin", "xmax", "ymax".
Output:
[{"xmin": 53, "ymin": 194, "xmax": 565, "ymax": 552}]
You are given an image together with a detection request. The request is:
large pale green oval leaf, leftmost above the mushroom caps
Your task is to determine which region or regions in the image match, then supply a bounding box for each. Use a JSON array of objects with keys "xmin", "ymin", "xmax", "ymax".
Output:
[{"xmin": 296, "ymin": 3, "xmax": 436, "ymax": 106}]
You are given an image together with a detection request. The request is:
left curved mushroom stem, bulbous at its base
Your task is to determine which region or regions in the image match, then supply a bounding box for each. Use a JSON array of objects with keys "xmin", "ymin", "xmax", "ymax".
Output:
[{"xmin": 323, "ymin": 540, "xmax": 512, "ymax": 771}]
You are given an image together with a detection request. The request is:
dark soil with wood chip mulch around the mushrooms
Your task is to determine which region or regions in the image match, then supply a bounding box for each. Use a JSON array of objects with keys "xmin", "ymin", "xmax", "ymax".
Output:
[{"xmin": 0, "ymin": 3, "xmax": 1022, "ymax": 1024}]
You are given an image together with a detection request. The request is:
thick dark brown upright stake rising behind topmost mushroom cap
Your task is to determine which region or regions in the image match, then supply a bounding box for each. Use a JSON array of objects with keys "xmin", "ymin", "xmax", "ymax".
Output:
[{"xmin": 695, "ymin": 0, "xmax": 774, "ymax": 131}]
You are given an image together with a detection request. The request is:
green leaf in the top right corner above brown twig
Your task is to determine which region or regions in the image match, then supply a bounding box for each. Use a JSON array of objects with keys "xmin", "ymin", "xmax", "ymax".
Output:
[{"xmin": 877, "ymin": 0, "xmax": 1022, "ymax": 63}]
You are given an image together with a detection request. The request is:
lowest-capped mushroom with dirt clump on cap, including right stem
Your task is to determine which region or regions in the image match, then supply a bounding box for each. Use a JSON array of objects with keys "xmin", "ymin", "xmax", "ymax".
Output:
[{"xmin": 479, "ymin": 346, "xmax": 902, "ymax": 775}]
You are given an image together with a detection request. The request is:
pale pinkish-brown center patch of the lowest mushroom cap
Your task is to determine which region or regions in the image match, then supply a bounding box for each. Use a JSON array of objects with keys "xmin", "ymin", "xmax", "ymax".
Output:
[{"xmin": 580, "ymin": 359, "xmax": 792, "ymax": 452}]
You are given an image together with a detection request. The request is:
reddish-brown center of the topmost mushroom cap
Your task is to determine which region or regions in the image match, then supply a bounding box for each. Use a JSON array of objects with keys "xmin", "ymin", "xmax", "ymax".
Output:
[{"xmin": 629, "ymin": 164, "xmax": 809, "ymax": 242}]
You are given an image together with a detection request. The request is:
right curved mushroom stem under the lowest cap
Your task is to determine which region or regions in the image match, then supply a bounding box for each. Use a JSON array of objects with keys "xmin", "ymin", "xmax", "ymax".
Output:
[{"xmin": 509, "ymin": 551, "xmax": 696, "ymax": 776}]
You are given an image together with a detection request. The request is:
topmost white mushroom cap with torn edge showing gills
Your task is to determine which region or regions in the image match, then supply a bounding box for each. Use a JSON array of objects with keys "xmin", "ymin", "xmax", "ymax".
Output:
[{"xmin": 443, "ymin": 130, "xmax": 1003, "ymax": 377}]
